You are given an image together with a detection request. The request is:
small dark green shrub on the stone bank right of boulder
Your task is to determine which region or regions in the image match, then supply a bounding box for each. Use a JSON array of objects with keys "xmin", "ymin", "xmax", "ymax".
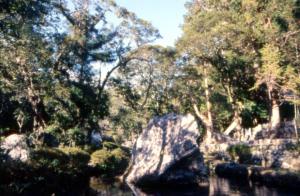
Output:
[{"xmin": 227, "ymin": 144, "xmax": 252, "ymax": 163}]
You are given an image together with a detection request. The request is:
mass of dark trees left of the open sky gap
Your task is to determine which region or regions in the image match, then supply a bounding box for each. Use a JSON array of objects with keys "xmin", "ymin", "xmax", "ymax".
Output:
[{"xmin": 0, "ymin": 0, "xmax": 159, "ymax": 139}]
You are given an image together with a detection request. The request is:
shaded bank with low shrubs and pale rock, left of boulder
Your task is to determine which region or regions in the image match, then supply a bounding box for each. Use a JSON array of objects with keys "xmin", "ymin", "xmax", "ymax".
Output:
[{"xmin": 0, "ymin": 134, "xmax": 130, "ymax": 195}]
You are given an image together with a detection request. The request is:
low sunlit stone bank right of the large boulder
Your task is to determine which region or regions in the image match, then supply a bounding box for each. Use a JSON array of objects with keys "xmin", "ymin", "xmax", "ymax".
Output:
[{"xmin": 202, "ymin": 136, "xmax": 300, "ymax": 190}]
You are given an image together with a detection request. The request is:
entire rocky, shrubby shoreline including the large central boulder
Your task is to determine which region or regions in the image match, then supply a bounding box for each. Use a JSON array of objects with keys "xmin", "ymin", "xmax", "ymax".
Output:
[{"xmin": 0, "ymin": 114, "xmax": 300, "ymax": 192}]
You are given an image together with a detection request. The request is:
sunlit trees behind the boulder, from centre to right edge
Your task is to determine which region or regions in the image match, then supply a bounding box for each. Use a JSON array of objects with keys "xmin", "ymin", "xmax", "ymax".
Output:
[{"xmin": 111, "ymin": 0, "xmax": 300, "ymax": 142}]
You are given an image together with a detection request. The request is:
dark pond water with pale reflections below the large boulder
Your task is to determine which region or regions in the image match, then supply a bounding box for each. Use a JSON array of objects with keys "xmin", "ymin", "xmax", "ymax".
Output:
[{"xmin": 89, "ymin": 177, "xmax": 300, "ymax": 196}]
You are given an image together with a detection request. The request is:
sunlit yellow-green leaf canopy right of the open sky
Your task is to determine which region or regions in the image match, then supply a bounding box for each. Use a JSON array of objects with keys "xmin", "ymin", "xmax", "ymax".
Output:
[{"xmin": 177, "ymin": 0, "xmax": 299, "ymax": 134}]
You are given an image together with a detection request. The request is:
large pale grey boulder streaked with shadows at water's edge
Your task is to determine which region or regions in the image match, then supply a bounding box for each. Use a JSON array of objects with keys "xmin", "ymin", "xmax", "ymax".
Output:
[{"xmin": 126, "ymin": 114, "xmax": 207, "ymax": 186}]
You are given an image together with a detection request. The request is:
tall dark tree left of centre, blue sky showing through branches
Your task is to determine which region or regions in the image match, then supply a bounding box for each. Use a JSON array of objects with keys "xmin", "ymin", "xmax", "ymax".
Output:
[{"xmin": 50, "ymin": 0, "xmax": 158, "ymax": 132}]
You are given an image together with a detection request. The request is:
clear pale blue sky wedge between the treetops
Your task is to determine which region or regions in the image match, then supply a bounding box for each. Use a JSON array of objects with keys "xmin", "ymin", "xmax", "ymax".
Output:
[{"xmin": 116, "ymin": 0, "xmax": 187, "ymax": 46}]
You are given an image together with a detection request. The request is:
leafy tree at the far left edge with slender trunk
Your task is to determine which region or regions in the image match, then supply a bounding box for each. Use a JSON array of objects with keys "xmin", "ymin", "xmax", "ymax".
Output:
[{"xmin": 0, "ymin": 1, "xmax": 50, "ymax": 130}]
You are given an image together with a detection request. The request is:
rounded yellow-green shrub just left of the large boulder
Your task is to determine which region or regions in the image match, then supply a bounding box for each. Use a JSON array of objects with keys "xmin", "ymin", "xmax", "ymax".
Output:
[{"xmin": 90, "ymin": 148, "xmax": 129, "ymax": 177}]
